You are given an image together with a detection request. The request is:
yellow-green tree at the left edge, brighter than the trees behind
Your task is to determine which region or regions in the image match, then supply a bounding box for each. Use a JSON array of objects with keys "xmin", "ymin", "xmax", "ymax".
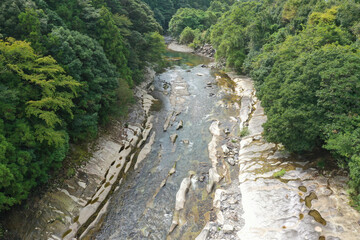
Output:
[{"xmin": 0, "ymin": 38, "xmax": 80, "ymax": 209}]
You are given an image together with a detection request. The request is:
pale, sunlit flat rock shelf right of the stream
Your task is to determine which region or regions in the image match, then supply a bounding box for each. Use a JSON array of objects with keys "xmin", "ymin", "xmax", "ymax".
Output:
[{"xmin": 199, "ymin": 74, "xmax": 360, "ymax": 240}]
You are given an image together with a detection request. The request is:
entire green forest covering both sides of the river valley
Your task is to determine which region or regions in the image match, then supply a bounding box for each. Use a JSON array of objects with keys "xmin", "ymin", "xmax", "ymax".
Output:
[{"xmin": 0, "ymin": 0, "xmax": 360, "ymax": 218}]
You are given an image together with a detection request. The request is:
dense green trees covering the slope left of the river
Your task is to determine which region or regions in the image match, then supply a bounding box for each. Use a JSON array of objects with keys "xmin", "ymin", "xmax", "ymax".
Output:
[{"xmin": 0, "ymin": 0, "xmax": 165, "ymax": 211}]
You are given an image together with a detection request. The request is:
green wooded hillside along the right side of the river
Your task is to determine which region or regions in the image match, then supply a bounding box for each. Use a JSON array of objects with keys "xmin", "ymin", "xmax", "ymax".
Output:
[{"xmin": 169, "ymin": 0, "xmax": 360, "ymax": 206}]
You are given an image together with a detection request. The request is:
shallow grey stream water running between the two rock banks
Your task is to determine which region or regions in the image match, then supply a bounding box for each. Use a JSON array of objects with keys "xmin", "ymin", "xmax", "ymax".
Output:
[{"xmin": 96, "ymin": 49, "xmax": 238, "ymax": 239}]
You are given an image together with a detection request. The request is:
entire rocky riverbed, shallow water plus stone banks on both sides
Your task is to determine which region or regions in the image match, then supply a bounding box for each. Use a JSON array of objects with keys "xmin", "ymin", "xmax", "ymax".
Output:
[{"xmin": 4, "ymin": 47, "xmax": 360, "ymax": 240}]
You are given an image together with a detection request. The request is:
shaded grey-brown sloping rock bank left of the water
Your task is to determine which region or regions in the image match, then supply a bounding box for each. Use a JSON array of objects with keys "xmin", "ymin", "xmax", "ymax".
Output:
[{"xmin": 4, "ymin": 69, "xmax": 155, "ymax": 240}]
